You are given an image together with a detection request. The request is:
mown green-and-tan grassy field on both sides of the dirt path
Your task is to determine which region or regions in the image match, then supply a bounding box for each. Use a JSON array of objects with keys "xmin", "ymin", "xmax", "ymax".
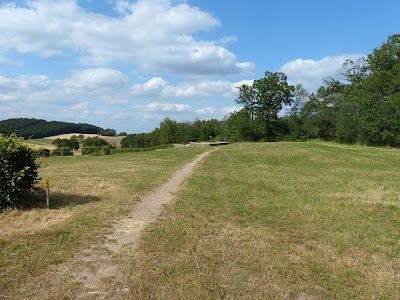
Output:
[{"xmin": 0, "ymin": 142, "xmax": 400, "ymax": 300}]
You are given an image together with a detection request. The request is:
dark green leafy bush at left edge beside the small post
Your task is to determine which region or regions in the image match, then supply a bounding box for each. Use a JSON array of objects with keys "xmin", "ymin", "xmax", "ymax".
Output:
[{"xmin": 0, "ymin": 134, "xmax": 39, "ymax": 208}]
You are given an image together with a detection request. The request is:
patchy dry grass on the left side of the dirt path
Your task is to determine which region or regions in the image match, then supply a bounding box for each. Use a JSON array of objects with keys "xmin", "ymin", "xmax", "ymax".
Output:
[{"xmin": 0, "ymin": 149, "xmax": 206, "ymax": 299}]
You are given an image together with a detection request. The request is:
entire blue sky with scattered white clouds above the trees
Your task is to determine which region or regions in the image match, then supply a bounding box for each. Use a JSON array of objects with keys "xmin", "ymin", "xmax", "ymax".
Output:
[{"xmin": 0, "ymin": 0, "xmax": 400, "ymax": 133}]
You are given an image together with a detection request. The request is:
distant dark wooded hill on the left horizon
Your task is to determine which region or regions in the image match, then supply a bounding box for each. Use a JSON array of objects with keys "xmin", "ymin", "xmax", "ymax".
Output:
[{"xmin": 0, "ymin": 118, "xmax": 104, "ymax": 138}]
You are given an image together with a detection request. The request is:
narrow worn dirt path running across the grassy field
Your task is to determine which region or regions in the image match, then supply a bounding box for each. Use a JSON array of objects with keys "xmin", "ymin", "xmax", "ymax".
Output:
[{"xmin": 71, "ymin": 150, "xmax": 214, "ymax": 299}]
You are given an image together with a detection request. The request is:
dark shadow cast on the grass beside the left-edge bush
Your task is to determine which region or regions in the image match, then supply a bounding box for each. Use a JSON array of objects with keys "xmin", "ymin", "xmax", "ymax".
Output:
[{"xmin": 21, "ymin": 189, "xmax": 101, "ymax": 210}]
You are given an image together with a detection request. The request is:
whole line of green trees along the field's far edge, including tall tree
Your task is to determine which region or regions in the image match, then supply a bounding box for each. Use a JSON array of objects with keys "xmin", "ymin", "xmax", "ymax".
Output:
[{"xmin": 121, "ymin": 34, "xmax": 400, "ymax": 148}]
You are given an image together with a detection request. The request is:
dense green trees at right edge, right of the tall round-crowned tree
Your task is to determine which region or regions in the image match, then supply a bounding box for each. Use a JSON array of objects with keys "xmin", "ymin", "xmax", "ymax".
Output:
[{"xmin": 290, "ymin": 34, "xmax": 400, "ymax": 147}]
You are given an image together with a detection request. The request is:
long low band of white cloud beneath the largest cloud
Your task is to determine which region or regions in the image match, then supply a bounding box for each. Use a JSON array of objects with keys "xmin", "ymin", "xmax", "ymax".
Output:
[{"xmin": 0, "ymin": 68, "xmax": 252, "ymax": 111}]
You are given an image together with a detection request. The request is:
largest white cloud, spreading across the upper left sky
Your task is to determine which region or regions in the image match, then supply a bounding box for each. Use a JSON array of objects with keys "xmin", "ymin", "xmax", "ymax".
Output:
[{"xmin": 0, "ymin": 0, "xmax": 255, "ymax": 75}]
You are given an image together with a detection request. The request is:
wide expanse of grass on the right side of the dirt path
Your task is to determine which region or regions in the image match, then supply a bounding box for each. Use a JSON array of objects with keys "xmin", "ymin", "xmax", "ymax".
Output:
[{"xmin": 118, "ymin": 142, "xmax": 400, "ymax": 299}]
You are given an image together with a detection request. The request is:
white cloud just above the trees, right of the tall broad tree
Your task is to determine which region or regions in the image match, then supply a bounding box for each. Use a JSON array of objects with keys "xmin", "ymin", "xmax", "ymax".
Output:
[{"xmin": 279, "ymin": 54, "xmax": 365, "ymax": 91}]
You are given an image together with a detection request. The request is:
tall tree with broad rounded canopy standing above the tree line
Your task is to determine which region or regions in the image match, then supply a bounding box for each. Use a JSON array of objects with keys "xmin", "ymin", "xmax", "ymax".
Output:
[{"xmin": 236, "ymin": 71, "xmax": 295, "ymax": 142}]
